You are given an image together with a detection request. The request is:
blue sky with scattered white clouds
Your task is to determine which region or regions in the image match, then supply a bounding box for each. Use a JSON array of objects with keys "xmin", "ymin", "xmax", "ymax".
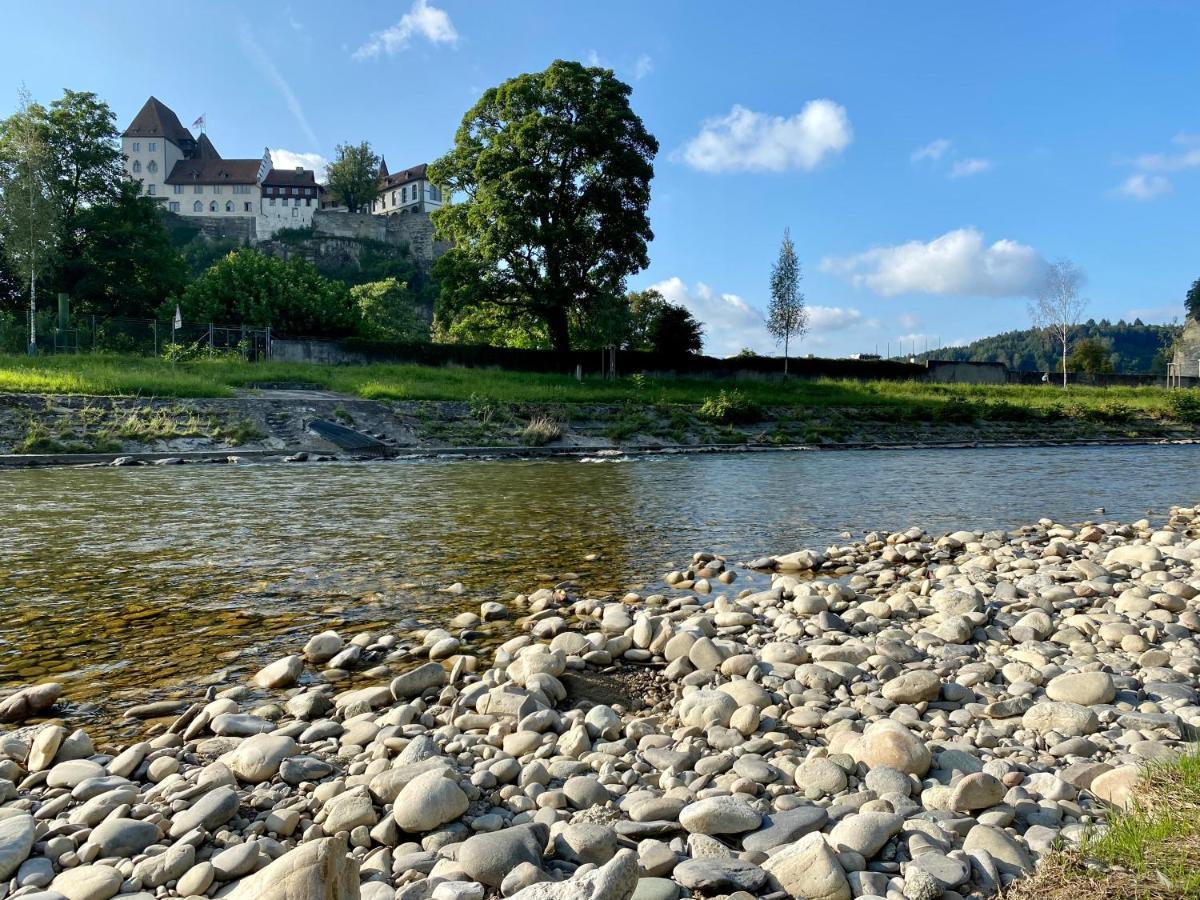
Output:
[{"xmin": 0, "ymin": 0, "xmax": 1200, "ymax": 356}]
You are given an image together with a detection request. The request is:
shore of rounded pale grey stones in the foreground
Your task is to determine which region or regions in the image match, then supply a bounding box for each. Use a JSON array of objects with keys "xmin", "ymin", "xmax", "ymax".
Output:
[{"xmin": 0, "ymin": 508, "xmax": 1200, "ymax": 900}]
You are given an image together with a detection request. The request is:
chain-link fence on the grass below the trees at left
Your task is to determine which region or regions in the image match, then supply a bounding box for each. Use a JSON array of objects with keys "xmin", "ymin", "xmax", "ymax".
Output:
[{"xmin": 0, "ymin": 310, "xmax": 270, "ymax": 361}]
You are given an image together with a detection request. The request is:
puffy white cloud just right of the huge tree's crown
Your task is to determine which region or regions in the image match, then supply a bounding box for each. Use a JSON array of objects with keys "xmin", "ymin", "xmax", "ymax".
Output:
[{"xmin": 682, "ymin": 100, "xmax": 854, "ymax": 173}]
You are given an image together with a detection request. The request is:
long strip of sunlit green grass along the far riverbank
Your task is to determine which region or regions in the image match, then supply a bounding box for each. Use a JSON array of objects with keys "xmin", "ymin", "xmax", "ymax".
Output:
[{"xmin": 0, "ymin": 354, "xmax": 1200, "ymax": 424}]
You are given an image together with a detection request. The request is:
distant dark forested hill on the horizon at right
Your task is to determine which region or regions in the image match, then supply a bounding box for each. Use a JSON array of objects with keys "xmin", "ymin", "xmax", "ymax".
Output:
[{"xmin": 917, "ymin": 319, "xmax": 1174, "ymax": 373}]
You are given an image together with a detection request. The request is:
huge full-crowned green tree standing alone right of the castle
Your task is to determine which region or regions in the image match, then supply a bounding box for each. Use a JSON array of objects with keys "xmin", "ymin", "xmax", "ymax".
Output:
[{"xmin": 430, "ymin": 60, "xmax": 659, "ymax": 350}]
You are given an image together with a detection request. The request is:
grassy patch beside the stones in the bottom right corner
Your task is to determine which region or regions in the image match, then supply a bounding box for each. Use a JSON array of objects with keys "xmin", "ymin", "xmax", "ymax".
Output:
[{"xmin": 1008, "ymin": 750, "xmax": 1200, "ymax": 900}]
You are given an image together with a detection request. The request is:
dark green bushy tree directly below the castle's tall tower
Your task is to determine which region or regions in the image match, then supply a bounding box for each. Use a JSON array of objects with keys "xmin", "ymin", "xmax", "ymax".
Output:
[{"xmin": 60, "ymin": 180, "xmax": 187, "ymax": 318}]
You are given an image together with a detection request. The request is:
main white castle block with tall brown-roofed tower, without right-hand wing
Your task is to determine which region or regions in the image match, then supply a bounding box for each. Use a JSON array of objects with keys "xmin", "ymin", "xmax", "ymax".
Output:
[{"xmin": 121, "ymin": 97, "xmax": 324, "ymax": 238}]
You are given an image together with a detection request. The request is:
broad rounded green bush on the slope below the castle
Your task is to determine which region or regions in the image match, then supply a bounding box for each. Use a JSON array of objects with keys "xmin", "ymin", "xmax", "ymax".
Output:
[{"xmin": 177, "ymin": 250, "xmax": 358, "ymax": 336}]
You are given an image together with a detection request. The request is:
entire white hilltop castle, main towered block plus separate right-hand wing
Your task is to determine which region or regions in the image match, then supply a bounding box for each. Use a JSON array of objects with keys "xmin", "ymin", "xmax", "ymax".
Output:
[{"xmin": 121, "ymin": 97, "xmax": 443, "ymax": 241}]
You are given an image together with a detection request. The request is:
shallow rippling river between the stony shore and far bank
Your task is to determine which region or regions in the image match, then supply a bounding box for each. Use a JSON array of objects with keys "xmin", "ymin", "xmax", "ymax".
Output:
[{"xmin": 0, "ymin": 446, "xmax": 1200, "ymax": 734}]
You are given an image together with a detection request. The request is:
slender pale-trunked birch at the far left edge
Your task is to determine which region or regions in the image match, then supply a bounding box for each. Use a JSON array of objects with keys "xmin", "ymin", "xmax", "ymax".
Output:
[{"xmin": 0, "ymin": 89, "xmax": 58, "ymax": 355}]
